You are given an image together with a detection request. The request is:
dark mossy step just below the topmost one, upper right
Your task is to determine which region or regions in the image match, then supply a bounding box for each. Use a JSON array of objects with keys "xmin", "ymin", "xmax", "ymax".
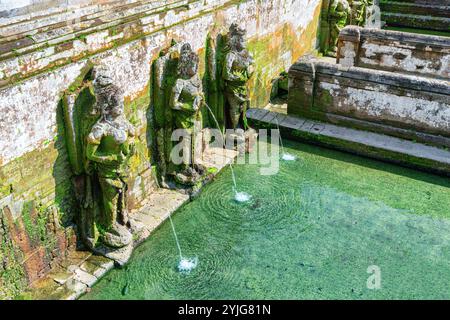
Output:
[{"xmin": 381, "ymin": 12, "xmax": 450, "ymax": 32}]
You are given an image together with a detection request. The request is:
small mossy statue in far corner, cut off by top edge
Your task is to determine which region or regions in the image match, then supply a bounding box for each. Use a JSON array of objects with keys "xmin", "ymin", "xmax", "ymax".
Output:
[{"xmin": 328, "ymin": 0, "xmax": 351, "ymax": 56}]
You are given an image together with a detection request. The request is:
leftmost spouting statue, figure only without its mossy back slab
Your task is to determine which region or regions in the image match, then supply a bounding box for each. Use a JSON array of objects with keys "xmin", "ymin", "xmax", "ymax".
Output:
[{"xmin": 86, "ymin": 69, "xmax": 135, "ymax": 258}]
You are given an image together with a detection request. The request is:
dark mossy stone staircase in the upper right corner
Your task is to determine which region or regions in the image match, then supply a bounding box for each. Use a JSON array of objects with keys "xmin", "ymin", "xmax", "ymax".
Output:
[{"xmin": 380, "ymin": 0, "xmax": 450, "ymax": 36}]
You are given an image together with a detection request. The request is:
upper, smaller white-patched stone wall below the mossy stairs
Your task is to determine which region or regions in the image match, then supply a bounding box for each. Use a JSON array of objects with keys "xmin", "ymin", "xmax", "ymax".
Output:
[{"xmin": 337, "ymin": 26, "xmax": 450, "ymax": 79}]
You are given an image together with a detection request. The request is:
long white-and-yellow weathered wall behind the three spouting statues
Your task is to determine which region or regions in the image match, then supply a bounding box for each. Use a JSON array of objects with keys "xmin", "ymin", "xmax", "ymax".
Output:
[{"xmin": 0, "ymin": 0, "xmax": 321, "ymax": 298}]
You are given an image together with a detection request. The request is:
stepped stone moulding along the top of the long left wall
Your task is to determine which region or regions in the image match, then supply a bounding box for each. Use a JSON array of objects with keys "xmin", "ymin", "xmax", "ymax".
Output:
[{"xmin": 0, "ymin": 0, "xmax": 229, "ymax": 88}]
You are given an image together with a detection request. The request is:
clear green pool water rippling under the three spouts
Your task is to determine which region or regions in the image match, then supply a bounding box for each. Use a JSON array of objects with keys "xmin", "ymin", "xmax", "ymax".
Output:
[{"xmin": 82, "ymin": 141, "xmax": 450, "ymax": 299}]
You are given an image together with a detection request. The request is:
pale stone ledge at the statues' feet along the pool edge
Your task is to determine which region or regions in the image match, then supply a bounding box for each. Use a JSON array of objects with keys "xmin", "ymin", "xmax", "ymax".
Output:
[{"xmin": 26, "ymin": 148, "xmax": 238, "ymax": 300}]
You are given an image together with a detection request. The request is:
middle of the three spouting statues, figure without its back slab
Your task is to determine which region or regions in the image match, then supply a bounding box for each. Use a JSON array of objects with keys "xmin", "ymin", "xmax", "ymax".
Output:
[{"xmin": 169, "ymin": 43, "xmax": 205, "ymax": 184}]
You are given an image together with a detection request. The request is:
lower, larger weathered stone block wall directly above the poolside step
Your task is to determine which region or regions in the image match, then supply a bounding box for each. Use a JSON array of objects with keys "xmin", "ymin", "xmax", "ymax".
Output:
[{"xmin": 288, "ymin": 58, "xmax": 450, "ymax": 147}]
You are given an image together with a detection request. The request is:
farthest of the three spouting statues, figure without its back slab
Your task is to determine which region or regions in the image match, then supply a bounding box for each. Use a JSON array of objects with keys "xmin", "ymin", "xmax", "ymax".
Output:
[{"xmin": 222, "ymin": 23, "xmax": 255, "ymax": 130}]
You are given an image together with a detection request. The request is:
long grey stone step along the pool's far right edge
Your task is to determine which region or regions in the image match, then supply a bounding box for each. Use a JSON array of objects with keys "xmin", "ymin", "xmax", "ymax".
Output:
[{"xmin": 247, "ymin": 109, "xmax": 450, "ymax": 176}]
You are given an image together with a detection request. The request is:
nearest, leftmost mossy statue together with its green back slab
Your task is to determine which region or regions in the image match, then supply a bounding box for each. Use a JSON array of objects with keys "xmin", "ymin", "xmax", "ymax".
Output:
[{"xmin": 63, "ymin": 67, "xmax": 135, "ymax": 265}]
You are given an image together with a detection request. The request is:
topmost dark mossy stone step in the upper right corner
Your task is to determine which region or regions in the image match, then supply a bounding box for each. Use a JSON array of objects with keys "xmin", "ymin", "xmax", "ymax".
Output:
[{"xmin": 380, "ymin": 1, "xmax": 450, "ymax": 18}]
